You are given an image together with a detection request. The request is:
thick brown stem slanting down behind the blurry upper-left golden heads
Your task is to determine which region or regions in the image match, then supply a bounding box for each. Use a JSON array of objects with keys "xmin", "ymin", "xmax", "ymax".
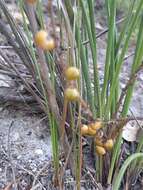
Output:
[{"xmin": 26, "ymin": 1, "xmax": 73, "ymax": 177}]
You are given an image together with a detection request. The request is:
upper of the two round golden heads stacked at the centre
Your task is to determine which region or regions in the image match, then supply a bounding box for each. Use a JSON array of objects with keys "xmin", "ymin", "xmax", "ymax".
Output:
[{"xmin": 65, "ymin": 67, "xmax": 80, "ymax": 80}]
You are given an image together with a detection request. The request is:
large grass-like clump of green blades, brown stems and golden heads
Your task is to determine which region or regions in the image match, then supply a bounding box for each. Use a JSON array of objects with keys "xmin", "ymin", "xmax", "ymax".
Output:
[{"xmin": 0, "ymin": 0, "xmax": 143, "ymax": 190}]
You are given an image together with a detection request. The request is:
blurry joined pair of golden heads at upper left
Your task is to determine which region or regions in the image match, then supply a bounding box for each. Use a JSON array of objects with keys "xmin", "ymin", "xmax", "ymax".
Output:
[{"xmin": 35, "ymin": 30, "xmax": 55, "ymax": 51}]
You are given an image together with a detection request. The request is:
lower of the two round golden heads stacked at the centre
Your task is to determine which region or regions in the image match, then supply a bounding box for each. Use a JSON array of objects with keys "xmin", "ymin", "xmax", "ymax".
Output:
[{"xmin": 65, "ymin": 88, "xmax": 80, "ymax": 101}]
